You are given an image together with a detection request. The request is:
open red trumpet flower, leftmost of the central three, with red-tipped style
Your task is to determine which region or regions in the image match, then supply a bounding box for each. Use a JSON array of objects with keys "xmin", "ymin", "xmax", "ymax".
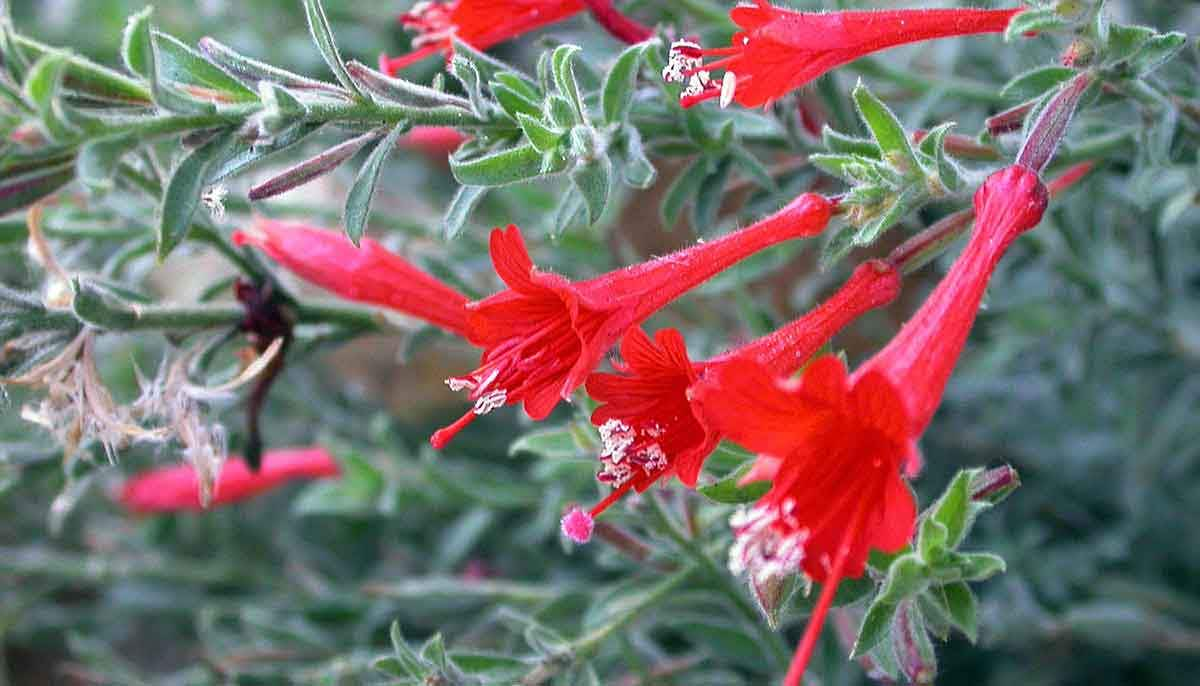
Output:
[{"xmin": 431, "ymin": 193, "xmax": 833, "ymax": 449}]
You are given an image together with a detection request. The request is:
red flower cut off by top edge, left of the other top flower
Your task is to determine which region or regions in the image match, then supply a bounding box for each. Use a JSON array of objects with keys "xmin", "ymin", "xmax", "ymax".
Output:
[{"xmin": 379, "ymin": 0, "xmax": 584, "ymax": 76}]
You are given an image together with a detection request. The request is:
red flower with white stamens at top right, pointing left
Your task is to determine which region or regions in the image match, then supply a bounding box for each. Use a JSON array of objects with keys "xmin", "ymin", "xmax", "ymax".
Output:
[{"xmin": 662, "ymin": 0, "xmax": 1021, "ymax": 107}]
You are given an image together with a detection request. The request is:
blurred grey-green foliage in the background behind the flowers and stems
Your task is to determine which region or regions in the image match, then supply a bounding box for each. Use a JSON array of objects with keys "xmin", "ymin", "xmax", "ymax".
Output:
[{"xmin": 0, "ymin": 0, "xmax": 1200, "ymax": 686}]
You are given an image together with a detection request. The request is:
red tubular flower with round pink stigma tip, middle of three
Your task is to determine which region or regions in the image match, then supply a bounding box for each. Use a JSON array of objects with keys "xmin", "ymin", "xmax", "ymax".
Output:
[{"xmin": 564, "ymin": 260, "xmax": 900, "ymax": 542}]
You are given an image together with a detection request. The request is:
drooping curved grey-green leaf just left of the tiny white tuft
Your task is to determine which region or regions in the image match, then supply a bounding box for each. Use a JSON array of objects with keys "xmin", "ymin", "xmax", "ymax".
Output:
[{"xmin": 156, "ymin": 131, "xmax": 236, "ymax": 256}]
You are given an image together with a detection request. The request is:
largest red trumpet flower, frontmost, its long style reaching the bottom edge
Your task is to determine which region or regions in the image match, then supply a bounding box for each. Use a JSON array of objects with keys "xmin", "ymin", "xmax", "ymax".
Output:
[{"xmin": 694, "ymin": 167, "xmax": 1048, "ymax": 686}]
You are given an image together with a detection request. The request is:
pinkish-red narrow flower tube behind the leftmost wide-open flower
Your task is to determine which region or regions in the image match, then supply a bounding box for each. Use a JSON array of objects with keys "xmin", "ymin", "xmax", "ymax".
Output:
[{"xmin": 233, "ymin": 217, "xmax": 467, "ymax": 336}]
